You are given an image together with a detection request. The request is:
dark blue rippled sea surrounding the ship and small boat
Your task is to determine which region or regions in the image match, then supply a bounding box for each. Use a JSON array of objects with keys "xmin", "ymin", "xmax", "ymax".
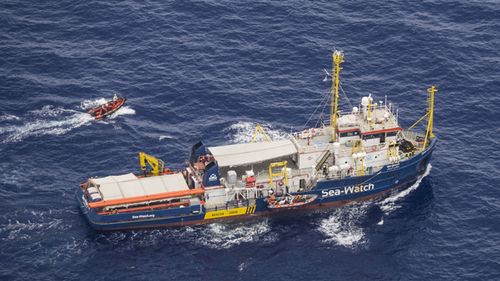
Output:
[{"xmin": 0, "ymin": 0, "xmax": 500, "ymax": 280}]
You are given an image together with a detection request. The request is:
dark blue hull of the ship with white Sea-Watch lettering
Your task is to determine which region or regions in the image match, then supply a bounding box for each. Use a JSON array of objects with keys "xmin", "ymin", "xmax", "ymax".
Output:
[{"xmin": 76, "ymin": 139, "xmax": 437, "ymax": 231}]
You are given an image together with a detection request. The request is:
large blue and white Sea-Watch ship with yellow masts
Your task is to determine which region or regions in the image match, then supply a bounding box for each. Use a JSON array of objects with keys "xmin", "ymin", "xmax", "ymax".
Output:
[{"xmin": 76, "ymin": 50, "xmax": 437, "ymax": 231}]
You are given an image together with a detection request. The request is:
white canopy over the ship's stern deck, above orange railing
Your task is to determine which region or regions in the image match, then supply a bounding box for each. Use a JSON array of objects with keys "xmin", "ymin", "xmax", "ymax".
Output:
[{"xmin": 91, "ymin": 173, "xmax": 189, "ymax": 200}]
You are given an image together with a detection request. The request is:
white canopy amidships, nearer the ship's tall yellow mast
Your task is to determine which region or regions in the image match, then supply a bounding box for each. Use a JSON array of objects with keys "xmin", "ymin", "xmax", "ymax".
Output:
[{"xmin": 208, "ymin": 140, "xmax": 297, "ymax": 167}]
